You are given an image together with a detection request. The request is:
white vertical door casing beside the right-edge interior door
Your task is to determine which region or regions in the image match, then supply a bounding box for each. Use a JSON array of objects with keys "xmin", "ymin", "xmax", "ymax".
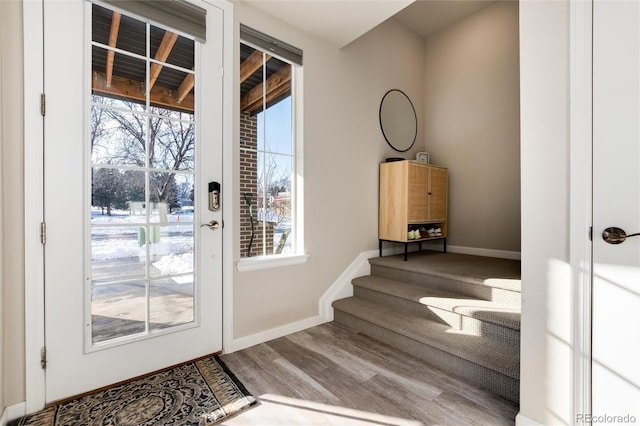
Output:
[{"xmin": 569, "ymin": 0, "xmax": 593, "ymax": 419}]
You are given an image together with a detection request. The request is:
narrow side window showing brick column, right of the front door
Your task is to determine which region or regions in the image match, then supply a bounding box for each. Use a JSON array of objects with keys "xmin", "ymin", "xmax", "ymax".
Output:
[{"xmin": 239, "ymin": 27, "xmax": 302, "ymax": 257}]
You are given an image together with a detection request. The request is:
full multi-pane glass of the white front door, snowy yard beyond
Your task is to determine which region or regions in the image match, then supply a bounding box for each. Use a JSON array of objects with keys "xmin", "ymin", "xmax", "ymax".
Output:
[{"xmin": 86, "ymin": 4, "xmax": 197, "ymax": 345}]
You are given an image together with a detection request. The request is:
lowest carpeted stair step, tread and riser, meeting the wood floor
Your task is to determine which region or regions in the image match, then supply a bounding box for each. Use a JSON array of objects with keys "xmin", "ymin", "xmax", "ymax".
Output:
[{"xmin": 333, "ymin": 297, "xmax": 520, "ymax": 401}]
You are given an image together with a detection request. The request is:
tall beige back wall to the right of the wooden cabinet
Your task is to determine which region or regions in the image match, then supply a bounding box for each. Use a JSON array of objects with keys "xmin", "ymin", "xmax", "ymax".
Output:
[{"xmin": 425, "ymin": 1, "xmax": 520, "ymax": 252}]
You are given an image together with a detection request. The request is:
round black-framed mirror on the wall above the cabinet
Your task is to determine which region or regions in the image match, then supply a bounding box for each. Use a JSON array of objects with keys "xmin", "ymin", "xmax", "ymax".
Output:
[{"xmin": 380, "ymin": 89, "xmax": 418, "ymax": 152}]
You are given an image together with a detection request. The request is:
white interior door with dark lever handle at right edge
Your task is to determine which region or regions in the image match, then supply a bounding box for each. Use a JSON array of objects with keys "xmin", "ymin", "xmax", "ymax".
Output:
[{"xmin": 592, "ymin": 0, "xmax": 640, "ymax": 423}]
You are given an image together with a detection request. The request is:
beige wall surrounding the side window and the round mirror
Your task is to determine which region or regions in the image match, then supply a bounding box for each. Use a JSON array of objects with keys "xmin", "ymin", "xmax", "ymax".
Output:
[{"xmin": 233, "ymin": 3, "xmax": 424, "ymax": 339}]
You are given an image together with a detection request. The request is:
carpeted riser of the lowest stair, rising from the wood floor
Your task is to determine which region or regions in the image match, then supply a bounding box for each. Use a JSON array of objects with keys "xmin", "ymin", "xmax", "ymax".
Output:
[{"xmin": 334, "ymin": 310, "xmax": 520, "ymax": 402}]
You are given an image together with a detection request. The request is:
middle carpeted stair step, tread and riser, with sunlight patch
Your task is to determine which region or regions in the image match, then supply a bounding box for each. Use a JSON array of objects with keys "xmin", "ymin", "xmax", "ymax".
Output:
[{"xmin": 352, "ymin": 275, "xmax": 520, "ymax": 346}]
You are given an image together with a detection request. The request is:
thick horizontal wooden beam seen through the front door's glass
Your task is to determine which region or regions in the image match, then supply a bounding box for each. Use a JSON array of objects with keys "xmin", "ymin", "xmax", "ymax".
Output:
[{"xmin": 91, "ymin": 71, "xmax": 194, "ymax": 113}]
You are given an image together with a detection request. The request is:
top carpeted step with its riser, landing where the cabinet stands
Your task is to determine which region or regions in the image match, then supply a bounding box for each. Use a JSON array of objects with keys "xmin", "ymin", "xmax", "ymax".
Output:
[{"xmin": 369, "ymin": 250, "xmax": 521, "ymax": 306}]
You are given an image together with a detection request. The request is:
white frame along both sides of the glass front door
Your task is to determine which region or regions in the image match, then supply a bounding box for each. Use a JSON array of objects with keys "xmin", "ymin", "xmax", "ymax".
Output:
[{"xmin": 23, "ymin": 0, "xmax": 237, "ymax": 413}]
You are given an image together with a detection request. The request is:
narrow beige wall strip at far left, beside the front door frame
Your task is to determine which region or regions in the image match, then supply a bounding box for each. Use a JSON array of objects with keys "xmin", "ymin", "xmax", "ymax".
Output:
[{"xmin": 0, "ymin": 1, "xmax": 25, "ymax": 415}]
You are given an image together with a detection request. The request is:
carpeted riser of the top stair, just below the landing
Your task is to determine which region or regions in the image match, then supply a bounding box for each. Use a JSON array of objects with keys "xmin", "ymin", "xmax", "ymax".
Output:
[{"xmin": 371, "ymin": 264, "xmax": 521, "ymax": 307}]
